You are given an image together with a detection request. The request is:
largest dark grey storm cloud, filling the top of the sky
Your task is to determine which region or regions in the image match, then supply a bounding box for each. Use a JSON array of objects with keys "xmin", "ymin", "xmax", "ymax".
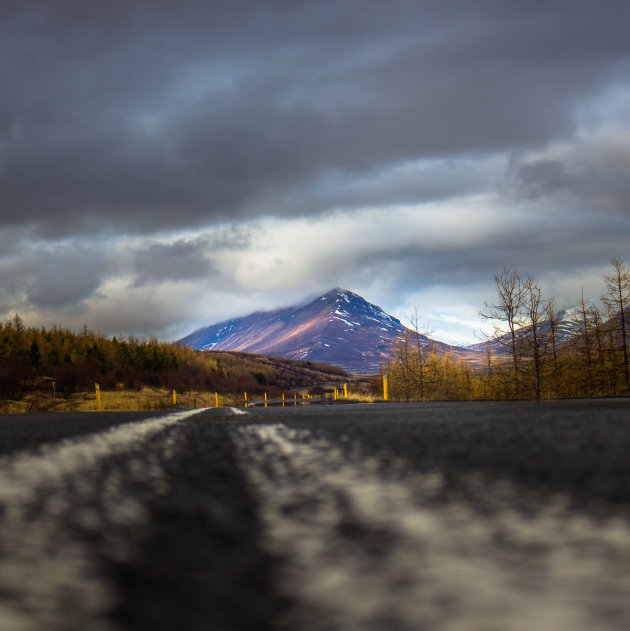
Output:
[{"xmin": 0, "ymin": 0, "xmax": 630, "ymax": 236}]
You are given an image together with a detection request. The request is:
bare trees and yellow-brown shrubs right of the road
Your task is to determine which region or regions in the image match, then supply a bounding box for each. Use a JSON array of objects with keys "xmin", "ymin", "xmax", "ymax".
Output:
[{"xmin": 387, "ymin": 257, "xmax": 630, "ymax": 401}]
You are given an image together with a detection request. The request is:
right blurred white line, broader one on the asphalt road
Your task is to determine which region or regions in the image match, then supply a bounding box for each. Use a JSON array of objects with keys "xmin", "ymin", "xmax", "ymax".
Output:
[{"xmin": 234, "ymin": 425, "xmax": 630, "ymax": 631}]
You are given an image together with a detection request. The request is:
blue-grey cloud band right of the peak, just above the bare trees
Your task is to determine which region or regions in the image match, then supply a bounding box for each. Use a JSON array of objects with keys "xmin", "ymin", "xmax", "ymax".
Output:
[{"xmin": 344, "ymin": 210, "xmax": 630, "ymax": 294}]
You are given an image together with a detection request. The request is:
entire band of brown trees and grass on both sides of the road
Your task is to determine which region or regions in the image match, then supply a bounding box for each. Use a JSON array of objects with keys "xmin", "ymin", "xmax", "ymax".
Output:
[{"xmin": 0, "ymin": 258, "xmax": 630, "ymax": 412}]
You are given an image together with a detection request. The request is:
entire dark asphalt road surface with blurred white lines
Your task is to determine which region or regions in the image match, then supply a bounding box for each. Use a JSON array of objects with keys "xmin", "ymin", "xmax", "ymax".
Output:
[{"xmin": 0, "ymin": 399, "xmax": 630, "ymax": 631}]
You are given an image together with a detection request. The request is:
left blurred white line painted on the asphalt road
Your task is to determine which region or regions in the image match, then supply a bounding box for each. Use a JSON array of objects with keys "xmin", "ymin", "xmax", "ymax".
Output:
[{"xmin": 0, "ymin": 409, "xmax": 209, "ymax": 631}]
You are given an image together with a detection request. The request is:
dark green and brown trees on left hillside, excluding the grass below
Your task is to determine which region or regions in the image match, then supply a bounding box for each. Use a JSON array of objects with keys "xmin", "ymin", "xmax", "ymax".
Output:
[{"xmin": 0, "ymin": 314, "xmax": 267, "ymax": 399}]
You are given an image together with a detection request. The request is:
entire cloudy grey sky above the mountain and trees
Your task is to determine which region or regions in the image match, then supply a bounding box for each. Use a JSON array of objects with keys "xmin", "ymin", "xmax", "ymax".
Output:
[{"xmin": 0, "ymin": 0, "xmax": 630, "ymax": 342}]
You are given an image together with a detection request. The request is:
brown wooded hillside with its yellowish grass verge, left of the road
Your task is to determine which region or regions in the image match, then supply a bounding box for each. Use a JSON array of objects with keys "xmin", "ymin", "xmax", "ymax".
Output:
[{"xmin": 0, "ymin": 315, "xmax": 346, "ymax": 412}]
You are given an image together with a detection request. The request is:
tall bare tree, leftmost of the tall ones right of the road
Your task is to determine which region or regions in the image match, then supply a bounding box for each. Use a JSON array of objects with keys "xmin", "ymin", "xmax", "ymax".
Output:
[{"xmin": 480, "ymin": 267, "xmax": 525, "ymax": 399}]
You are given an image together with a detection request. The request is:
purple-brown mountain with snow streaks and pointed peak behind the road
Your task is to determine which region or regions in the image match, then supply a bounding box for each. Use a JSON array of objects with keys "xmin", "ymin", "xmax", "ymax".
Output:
[{"xmin": 179, "ymin": 287, "xmax": 464, "ymax": 374}]
